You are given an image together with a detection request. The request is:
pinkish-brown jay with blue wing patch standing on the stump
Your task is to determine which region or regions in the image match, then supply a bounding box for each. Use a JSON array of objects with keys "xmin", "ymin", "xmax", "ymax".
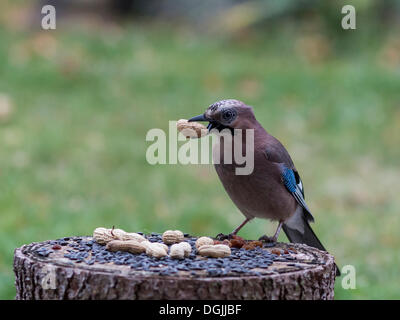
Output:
[{"xmin": 189, "ymin": 99, "xmax": 340, "ymax": 274}]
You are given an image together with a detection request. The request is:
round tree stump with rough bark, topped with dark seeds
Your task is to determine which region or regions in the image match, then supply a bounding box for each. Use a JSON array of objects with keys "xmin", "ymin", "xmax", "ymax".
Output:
[{"xmin": 14, "ymin": 237, "xmax": 336, "ymax": 300}]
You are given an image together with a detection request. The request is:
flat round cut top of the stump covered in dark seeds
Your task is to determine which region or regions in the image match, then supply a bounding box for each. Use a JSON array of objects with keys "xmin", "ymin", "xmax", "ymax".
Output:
[{"xmin": 15, "ymin": 234, "xmax": 334, "ymax": 280}]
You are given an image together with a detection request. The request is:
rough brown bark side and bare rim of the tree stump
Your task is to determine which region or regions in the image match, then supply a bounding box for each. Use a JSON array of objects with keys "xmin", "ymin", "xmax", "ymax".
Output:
[{"xmin": 14, "ymin": 238, "xmax": 336, "ymax": 300}]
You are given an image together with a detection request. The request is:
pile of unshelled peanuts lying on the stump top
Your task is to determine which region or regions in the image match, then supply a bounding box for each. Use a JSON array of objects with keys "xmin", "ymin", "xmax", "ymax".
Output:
[{"xmin": 93, "ymin": 228, "xmax": 262, "ymax": 259}]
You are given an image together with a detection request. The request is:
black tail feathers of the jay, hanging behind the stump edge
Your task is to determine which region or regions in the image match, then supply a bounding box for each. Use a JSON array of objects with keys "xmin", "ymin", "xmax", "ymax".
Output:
[{"xmin": 282, "ymin": 212, "xmax": 340, "ymax": 276}]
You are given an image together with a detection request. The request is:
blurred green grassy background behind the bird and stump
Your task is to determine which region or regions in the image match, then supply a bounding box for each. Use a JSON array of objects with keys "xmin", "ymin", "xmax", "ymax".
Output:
[{"xmin": 0, "ymin": 0, "xmax": 400, "ymax": 299}]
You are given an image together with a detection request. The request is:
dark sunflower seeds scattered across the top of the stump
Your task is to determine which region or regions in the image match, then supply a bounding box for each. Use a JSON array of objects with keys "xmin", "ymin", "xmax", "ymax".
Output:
[{"xmin": 35, "ymin": 233, "xmax": 319, "ymax": 277}]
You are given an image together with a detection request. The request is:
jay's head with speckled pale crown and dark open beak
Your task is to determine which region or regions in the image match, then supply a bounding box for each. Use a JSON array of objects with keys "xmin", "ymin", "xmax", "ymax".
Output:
[{"xmin": 189, "ymin": 99, "xmax": 255, "ymax": 131}]
